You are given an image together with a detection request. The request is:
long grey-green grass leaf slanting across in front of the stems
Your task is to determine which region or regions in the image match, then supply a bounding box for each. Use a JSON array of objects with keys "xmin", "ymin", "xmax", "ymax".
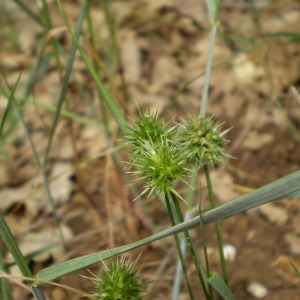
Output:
[{"xmin": 37, "ymin": 170, "xmax": 300, "ymax": 280}]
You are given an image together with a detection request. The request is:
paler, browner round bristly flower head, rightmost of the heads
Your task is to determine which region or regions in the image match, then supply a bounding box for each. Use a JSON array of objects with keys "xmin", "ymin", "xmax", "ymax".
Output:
[{"xmin": 179, "ymin": 116, "xmax": 229, "ymax": 167}]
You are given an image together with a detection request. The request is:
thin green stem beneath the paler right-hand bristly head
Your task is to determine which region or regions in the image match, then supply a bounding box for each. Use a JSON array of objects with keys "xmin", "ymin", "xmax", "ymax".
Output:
[{"xmin": 204, "ymin": 165, "xmax": 228, "ymax": 285}]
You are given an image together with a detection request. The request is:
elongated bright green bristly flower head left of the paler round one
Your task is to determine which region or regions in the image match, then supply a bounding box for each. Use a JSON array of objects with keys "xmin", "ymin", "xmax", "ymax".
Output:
[{"xmin": 125, "ymin": 112, "xmax": 186, "ymax": 199}]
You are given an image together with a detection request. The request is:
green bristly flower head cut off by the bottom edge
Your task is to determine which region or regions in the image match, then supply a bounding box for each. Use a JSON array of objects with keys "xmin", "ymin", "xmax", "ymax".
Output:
[{"xmin": 89, "ymin": 257, "xmax": 147, "ymax": 300}]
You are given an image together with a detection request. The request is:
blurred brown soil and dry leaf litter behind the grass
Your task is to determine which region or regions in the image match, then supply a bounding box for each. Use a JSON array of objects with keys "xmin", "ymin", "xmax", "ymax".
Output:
[{"xmin": 0, "ymin": 0, "xmax": 300, "ymax": 300}]
